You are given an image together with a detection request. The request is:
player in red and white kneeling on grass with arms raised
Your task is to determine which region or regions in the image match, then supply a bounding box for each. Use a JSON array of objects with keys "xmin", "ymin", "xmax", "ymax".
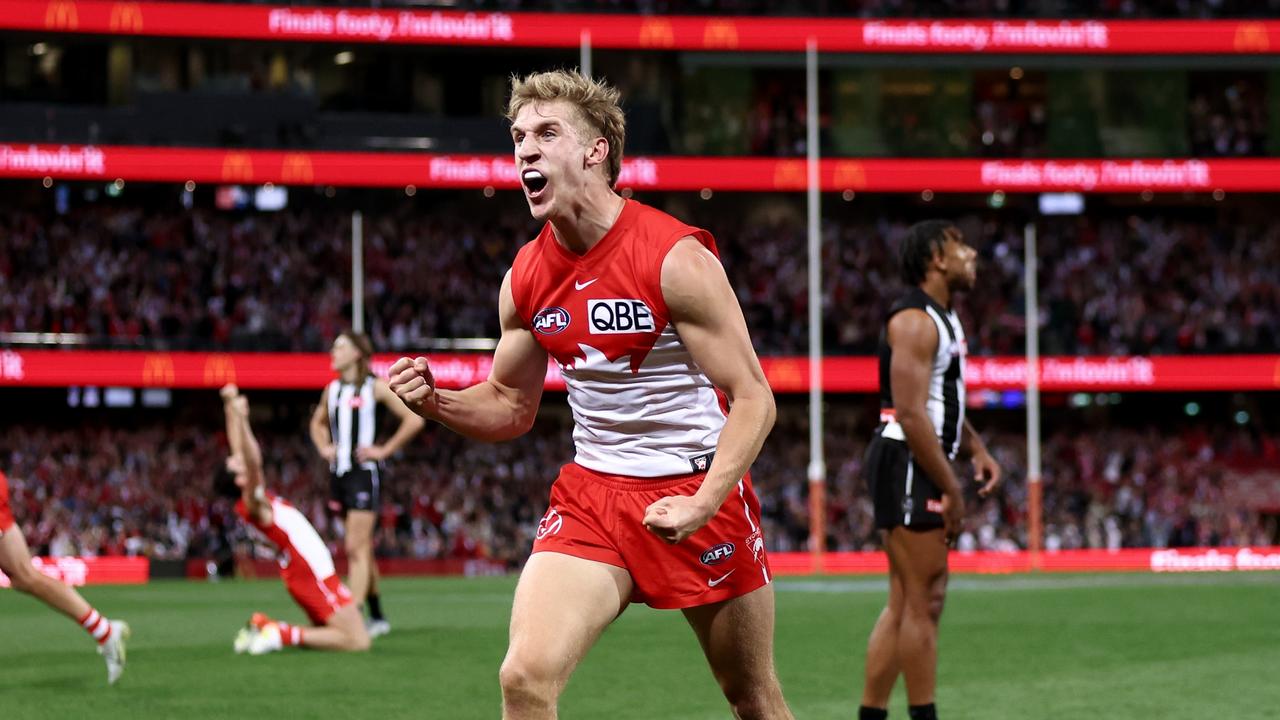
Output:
[{"xmin": 216, "ymin": 386, "xmax": 369, "ymax": 655}]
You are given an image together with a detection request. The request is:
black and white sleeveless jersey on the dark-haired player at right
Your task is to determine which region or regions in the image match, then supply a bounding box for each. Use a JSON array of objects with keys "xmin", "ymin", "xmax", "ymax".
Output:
[{"xmin": 879, "ymin": 287, "xmax": 969, "ymax": 460}]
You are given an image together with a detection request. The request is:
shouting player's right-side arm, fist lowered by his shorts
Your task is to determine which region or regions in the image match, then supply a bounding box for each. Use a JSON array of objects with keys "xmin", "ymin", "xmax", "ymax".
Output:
[{"xmin": 645, "ymin": 237, "xmax": 777, "ymax": 542}]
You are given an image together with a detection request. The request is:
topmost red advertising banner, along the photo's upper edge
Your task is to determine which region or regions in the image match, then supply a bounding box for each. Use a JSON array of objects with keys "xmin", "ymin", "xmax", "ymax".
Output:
[{"xmin": 0, "ymin": 0, "xmax": 1280, "ymax": 55}]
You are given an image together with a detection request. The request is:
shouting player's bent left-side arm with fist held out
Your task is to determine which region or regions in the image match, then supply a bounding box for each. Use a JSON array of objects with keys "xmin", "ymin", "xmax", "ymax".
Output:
[{"xmin": 390, "ymin": 272, "xmax": 547, "ymax": 442}]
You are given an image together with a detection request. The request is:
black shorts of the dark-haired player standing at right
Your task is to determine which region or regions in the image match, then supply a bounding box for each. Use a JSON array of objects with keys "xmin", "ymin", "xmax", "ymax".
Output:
[{"xmin": 863, "ymin": 427, "xmax": 943, "ymax": 530}]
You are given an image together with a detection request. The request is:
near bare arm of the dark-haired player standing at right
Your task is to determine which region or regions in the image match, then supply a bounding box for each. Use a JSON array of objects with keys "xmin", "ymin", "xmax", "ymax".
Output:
[{"xmin": 888, "ymin": 310, "xmax": 963, "ymax": 501}]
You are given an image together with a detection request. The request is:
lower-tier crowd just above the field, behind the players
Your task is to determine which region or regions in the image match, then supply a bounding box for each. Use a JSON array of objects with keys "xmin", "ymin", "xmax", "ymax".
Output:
[{"xmin": 0, "ymin": 398, "xmax": 1280, "ymax": 566}]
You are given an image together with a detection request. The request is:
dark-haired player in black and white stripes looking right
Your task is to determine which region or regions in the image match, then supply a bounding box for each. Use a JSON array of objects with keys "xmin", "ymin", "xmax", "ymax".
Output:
[{"xmin": 858, "ymin": 220, "xmax": 1000, "ymax": 720}]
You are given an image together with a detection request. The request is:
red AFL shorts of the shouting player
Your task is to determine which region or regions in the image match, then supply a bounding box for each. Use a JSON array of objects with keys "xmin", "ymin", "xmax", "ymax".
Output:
[{"xmin": 534, "ymin": 464, "xmax": 772, "ymax": 610}]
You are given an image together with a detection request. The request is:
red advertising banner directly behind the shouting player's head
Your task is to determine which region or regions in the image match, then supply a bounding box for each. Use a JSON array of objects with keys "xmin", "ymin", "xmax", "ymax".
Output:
[{"xmin": 0, "ymin": 142, "xmax": 1280, "ymax": 192}]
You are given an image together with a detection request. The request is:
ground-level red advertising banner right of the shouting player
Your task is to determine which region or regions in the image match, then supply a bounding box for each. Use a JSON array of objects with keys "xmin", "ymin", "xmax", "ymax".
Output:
[{"xmin": 769, "ymin": 547, "xmax": 1280, "ymax": 575}]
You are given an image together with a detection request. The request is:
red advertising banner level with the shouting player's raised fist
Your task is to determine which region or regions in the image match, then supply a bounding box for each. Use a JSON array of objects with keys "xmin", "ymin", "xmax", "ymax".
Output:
[{"xmin": 0, "ymin": 350, "xmax": 1280, "ymax": 393}]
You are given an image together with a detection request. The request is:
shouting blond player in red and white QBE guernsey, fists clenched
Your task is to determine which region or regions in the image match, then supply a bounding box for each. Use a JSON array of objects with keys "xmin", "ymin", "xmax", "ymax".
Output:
[{"xmin": 392, "ymin": 72, "xmax": 791, "ymax": 719}]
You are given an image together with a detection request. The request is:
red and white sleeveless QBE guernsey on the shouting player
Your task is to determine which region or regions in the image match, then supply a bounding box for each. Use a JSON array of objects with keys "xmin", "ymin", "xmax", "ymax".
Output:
[{"xmin": 511, "ymin": 200, "xmax": 724, "ymax": 478}]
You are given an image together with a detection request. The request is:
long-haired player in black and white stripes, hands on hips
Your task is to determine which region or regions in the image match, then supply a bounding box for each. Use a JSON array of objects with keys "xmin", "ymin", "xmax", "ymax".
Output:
[{"xmin": 311, "ymin": 331, "xmax": 425, "ymax": 637}]
